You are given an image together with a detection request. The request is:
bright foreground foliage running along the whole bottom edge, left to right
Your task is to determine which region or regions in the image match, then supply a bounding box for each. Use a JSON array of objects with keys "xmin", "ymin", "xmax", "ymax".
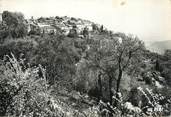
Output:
[{"xmin": 0, "ymin": 54, "xmax": 170, "ymax": 117}]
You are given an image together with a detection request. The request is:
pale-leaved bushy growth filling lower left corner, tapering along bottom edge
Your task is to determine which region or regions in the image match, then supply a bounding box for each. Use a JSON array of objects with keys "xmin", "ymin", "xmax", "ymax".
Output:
[{"xmin": 0, "ymin": 54, "xmax": 102, "ymax": 117}]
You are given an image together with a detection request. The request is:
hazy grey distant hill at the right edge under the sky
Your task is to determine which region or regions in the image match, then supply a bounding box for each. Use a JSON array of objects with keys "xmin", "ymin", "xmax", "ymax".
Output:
[{"xmin": 147, "ymin": 40, "xmax": 171, "ymax": 54}]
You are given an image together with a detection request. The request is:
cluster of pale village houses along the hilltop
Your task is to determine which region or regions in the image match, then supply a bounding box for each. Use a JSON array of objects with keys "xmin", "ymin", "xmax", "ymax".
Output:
[{"xmin": 26, "ymin": 16, "xmax": 100, "ymax": 35}]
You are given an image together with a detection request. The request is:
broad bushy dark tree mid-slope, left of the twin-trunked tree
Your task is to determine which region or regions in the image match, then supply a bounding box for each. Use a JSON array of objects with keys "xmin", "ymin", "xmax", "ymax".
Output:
[{"xmin": 33, "ymin": 35, "xmax": 80, "ymax": 87}]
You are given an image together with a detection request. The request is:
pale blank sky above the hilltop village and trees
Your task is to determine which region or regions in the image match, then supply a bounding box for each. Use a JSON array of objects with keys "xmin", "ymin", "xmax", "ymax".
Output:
[{"xmin": 0, "ymin": 0, "xmax": 171, "ymax": 42}]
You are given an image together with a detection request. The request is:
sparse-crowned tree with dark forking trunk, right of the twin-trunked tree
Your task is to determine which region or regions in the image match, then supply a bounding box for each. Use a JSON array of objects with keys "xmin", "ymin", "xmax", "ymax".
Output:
[{"xmin": 113, "ymin": 33, "xmax": 145, "ymax": 106}]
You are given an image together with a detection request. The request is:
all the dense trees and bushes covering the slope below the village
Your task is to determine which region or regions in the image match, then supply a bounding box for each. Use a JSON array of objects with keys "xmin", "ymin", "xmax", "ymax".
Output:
[{"xmin": 0, "ymin": 11, "xmax": 171, "ymax": 117}]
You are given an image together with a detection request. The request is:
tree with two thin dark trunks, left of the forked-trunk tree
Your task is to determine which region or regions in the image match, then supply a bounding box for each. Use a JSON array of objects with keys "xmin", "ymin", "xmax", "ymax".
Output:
[{"xmin": 86, "ymin": 34, "xmax": 118, "ymax": 103}]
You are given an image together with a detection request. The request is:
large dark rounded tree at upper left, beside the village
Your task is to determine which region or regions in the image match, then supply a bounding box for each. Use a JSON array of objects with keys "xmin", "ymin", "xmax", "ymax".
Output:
[{"xmin": 2, "ymin": 11, "xmax": 27, "ymax": 38}]
